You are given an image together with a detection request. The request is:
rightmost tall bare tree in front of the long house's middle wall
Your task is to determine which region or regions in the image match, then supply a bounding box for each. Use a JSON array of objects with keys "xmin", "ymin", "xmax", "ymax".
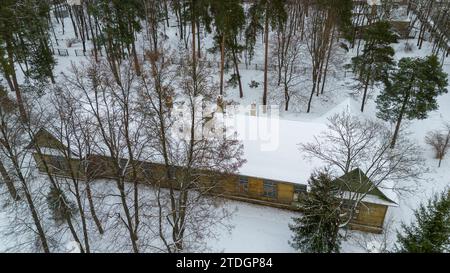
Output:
[{"xmin": 140, "ymin": 49, "xmax": 242, "ymax": 252}]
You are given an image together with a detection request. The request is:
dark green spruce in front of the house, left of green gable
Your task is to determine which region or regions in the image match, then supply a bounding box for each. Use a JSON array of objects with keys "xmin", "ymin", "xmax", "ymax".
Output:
[{"xmin": 289, "ymin": 170, "xmax": 341, "ymax": 253}]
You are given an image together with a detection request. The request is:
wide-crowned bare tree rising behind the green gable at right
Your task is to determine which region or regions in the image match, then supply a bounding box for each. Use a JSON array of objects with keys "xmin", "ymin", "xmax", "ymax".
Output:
[{"xmin": 300, "ymin": 111, "xmax": 425, "ymax": 225}]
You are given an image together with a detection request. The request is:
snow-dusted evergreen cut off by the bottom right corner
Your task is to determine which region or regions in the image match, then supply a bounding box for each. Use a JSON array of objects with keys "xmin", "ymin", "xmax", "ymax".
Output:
[{"xmin": 396, "ymin": 191, "xmax": 450, "ymax": 253}]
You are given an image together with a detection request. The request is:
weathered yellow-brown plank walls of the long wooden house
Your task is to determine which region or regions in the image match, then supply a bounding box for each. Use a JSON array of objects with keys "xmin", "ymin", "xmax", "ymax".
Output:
[{"xmin": 34, "ymin": 154, "xmax": 388, "ymax": 233}]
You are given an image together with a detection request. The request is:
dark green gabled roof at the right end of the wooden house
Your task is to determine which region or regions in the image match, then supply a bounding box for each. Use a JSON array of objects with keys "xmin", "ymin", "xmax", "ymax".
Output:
[{"xmin": 334, "ymin": 168, "xmax": 395, "ymax": 203}]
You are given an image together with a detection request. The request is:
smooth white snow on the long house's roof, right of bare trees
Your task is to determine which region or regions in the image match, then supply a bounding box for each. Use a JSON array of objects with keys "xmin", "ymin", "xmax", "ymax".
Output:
[{"xmin": 229, "ymin": 111, "xmax": 326, "ymax": 184}]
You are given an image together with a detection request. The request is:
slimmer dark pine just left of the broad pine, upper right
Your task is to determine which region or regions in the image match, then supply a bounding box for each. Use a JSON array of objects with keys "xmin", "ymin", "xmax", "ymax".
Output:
[{"xmin": 352, "ymin": 21, "xmax": 397, "ymax": 112}]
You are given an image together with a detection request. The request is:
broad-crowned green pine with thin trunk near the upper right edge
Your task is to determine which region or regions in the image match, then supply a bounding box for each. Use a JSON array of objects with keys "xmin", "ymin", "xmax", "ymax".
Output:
[{"xmin": 377, "ymin": 55, "xmax": 448, "ymax": 147}]
